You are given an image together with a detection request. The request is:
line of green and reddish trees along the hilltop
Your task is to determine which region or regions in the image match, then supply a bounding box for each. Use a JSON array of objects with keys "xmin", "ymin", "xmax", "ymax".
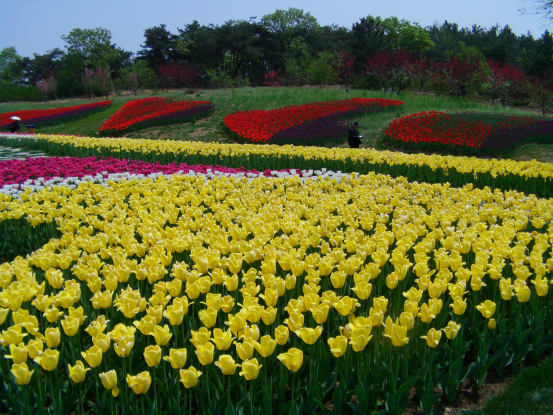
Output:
[{"xmin": 0, "ymin": 8, "xmax": 553, "ymax": 112}]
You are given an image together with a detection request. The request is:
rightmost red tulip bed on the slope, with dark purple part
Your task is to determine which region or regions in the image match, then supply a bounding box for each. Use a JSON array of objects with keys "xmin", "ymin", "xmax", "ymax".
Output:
[{"xmin": 384, "ymin": 111, "xmax": 553, "ymax": 155}]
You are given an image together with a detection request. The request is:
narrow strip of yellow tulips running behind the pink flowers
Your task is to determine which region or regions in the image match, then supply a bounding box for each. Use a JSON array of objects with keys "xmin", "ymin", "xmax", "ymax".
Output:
[{"xmin": 0, "ymin": 134, "xmax": 553, "ymax": 197}]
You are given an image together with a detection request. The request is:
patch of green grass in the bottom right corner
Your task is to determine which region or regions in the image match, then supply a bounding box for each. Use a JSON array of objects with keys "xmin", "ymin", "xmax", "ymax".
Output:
[{"xmin": 462, "ymin": 356, "xmax": 553, "ymax": 415}]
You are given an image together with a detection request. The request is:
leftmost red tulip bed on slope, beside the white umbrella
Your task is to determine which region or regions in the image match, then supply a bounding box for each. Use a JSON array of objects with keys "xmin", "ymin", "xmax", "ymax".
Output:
[{"xmin": 0, "ymin": 100, "xmax": 113, "ymax": 131}]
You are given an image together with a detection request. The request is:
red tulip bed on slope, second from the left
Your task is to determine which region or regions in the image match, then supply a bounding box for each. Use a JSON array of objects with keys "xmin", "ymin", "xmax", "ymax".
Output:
[{"xmin": 100, "ymin": 97, "xmax": 215, "ymax": 136}]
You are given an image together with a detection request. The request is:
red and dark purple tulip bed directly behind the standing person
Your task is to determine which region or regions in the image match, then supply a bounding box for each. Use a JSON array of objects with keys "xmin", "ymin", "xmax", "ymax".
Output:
[{"xmin": 224, "ymin": 98, "xmax": 403, "ymax": 145}]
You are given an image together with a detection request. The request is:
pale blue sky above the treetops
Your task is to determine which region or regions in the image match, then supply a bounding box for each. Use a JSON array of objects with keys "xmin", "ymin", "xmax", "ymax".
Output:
[{"xmin": 0, "ymin": 0, "xmax": 551, "ymax": 56}]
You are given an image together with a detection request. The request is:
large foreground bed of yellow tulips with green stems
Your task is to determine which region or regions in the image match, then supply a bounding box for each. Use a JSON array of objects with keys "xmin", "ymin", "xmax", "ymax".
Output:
[{"xmin": 0, "ymin": 173, "xmax": 553, "ymax": 413}]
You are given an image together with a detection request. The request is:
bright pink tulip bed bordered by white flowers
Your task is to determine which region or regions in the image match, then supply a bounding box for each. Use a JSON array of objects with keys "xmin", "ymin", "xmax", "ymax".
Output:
[{"xmin": 0, "ymin": 157, "xmax": 294, "ymax": 186}]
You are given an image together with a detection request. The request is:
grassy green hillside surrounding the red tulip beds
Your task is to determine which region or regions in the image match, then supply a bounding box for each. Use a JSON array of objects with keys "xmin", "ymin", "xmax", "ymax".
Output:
[{"xmin": 0, "ymin": 87, "xmax": 553, "ymax": 161}]
